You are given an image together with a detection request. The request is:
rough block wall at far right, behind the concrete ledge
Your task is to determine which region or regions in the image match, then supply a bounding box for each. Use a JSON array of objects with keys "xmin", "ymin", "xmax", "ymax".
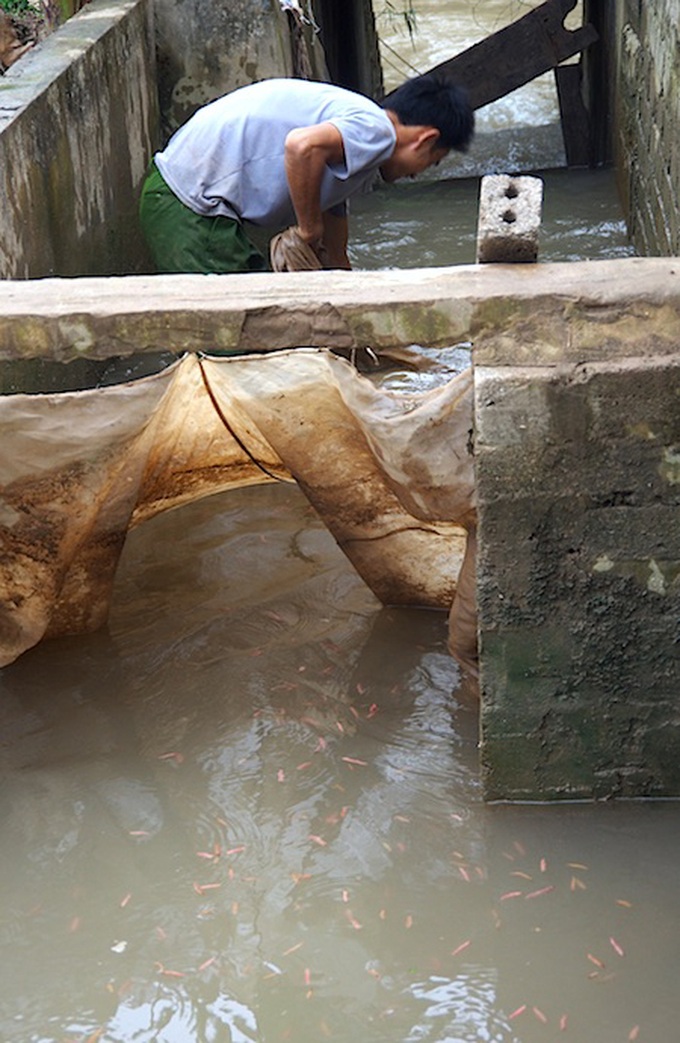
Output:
[{"xmin": 612, "ymin": 0, "xmax": 680, "ymax": 256}]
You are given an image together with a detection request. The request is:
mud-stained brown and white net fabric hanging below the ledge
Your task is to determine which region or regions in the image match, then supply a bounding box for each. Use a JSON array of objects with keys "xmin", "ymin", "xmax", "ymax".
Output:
[{"xmin": 0, "ymin": 348, "xmax": 473, "ymax": 665}]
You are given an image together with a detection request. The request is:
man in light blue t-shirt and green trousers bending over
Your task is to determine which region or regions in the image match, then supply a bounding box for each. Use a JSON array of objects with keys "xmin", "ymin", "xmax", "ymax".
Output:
[{"xmin": 140, "ymin": 73, "xmax": 475, "ymax": 273}]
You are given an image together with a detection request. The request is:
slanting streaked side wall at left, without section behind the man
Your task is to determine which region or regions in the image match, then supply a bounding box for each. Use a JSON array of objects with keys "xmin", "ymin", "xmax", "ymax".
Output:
[{"xmin": 0, "ymin": 0, "xmax": 159, "ymax": 278}]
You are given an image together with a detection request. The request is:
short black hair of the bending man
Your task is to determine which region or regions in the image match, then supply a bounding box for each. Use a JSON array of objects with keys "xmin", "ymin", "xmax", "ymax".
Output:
[{"xmin": 383, "ymin": 73, "xmax": 475, "ymax": 152}]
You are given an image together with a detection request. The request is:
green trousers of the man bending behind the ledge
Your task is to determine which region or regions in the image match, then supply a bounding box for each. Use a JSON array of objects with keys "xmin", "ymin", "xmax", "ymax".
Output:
[{"xmin": 140, "ymin": 162, "xmax": 269, "ymax": 274}]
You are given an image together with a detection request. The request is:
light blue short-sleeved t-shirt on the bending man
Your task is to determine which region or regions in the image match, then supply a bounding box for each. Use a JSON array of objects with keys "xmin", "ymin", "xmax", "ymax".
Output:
[{"xmin": 154, "ymin": 79, "xmax": 396, "ymax": 228}]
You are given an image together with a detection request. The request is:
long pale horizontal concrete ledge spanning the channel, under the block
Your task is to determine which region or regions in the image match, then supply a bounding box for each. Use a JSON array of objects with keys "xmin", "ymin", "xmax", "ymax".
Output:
[{"xmin": 0, "ymin": 258, "xmax": 680, "ymax": 366}]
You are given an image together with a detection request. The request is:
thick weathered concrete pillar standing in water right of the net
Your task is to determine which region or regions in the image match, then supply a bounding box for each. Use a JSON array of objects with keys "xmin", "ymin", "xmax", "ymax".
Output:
[{"xmin": 475, "ymin": 266, "xmax": 680, "ymax": 800}]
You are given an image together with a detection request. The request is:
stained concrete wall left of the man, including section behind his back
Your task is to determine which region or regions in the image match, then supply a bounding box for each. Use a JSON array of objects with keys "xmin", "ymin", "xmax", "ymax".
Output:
[{"xmin": 0, "ymin": 0, "xmax": 325, "ymax": 278}]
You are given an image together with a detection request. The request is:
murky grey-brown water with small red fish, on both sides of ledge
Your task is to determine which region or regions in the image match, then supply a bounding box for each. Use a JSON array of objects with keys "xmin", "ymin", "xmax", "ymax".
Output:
[{"xmin": 0, "ymin": 2, "xmax": 680, "ymax": 1043}]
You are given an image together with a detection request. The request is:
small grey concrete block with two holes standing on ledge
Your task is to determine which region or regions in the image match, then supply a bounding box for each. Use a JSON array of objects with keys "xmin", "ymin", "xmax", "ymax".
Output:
[{"xmin": 477, "ymin": 174, "xmax": 543, "ymax": 264}]
